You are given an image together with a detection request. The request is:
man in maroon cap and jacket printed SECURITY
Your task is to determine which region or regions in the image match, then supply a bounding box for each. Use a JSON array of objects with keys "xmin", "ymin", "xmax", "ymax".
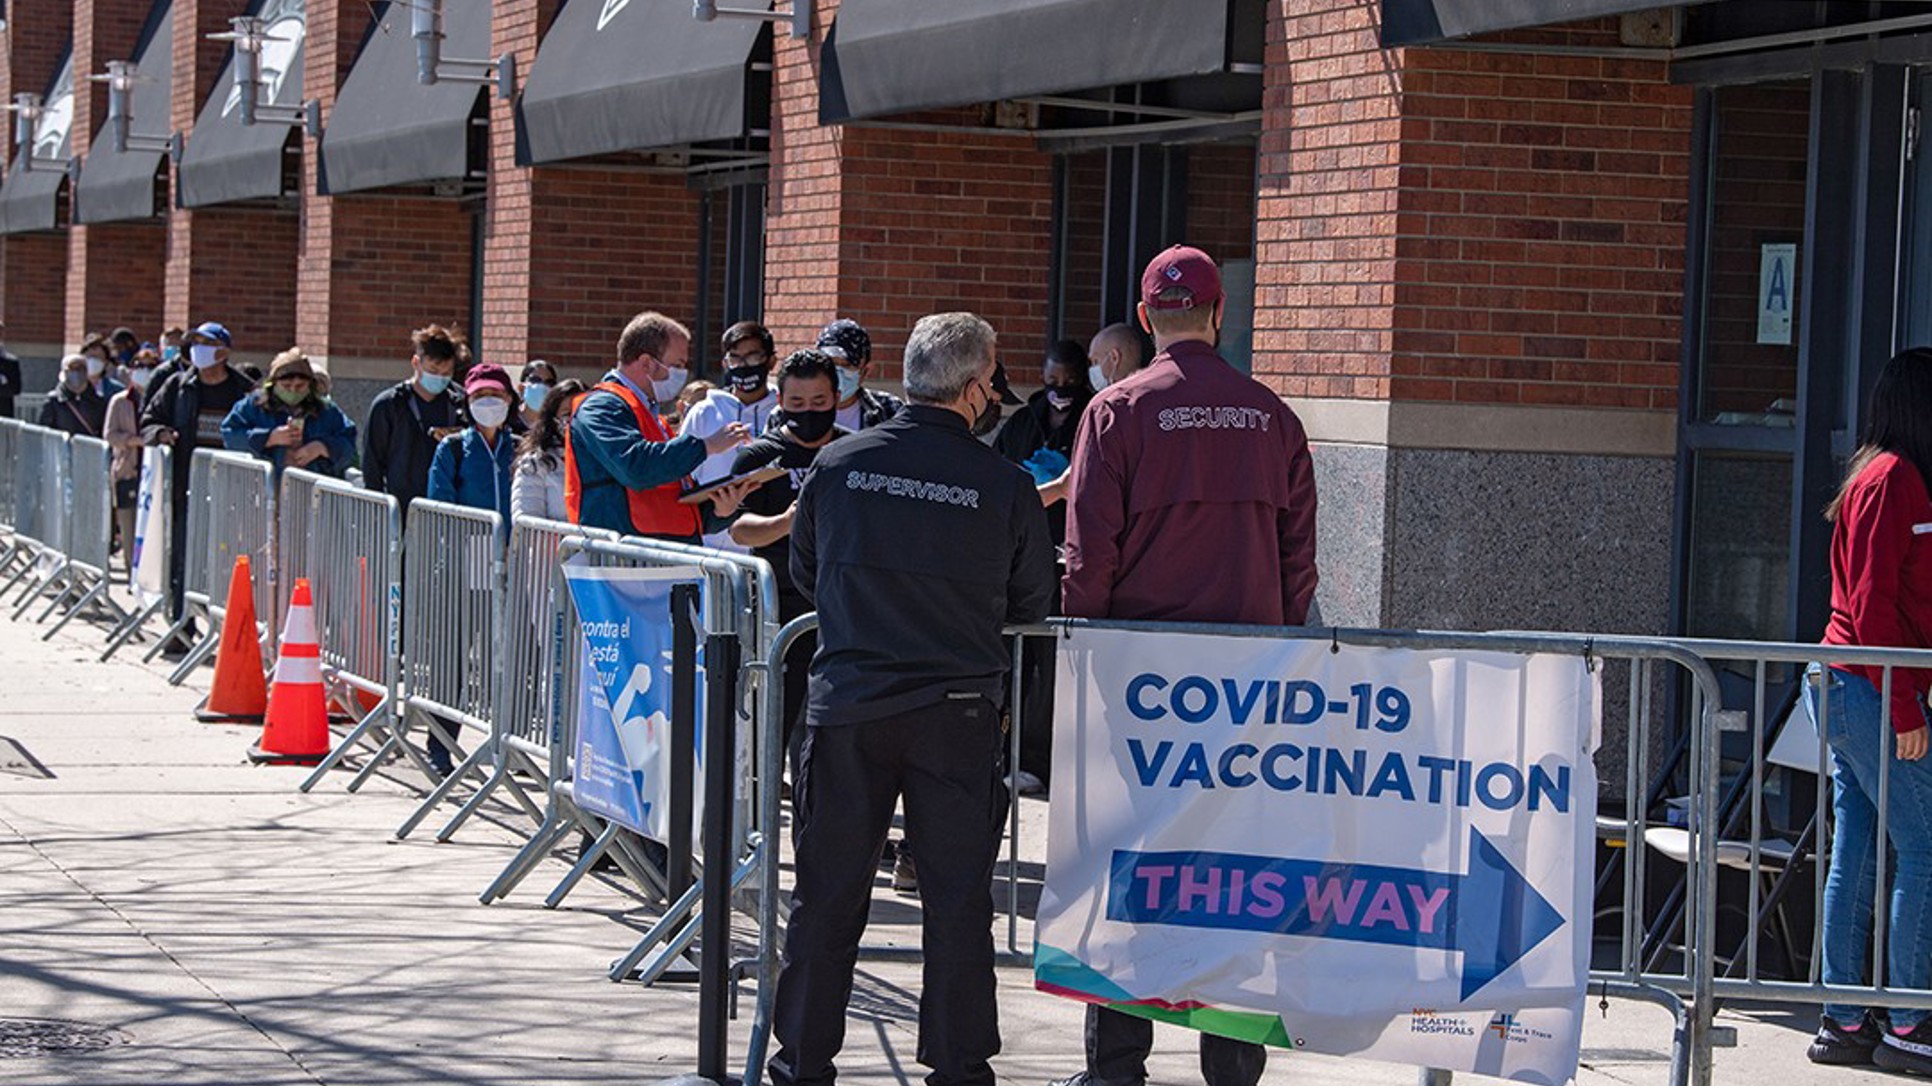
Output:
[{"xmin": 1055, "ymin": 245, "xmax": 1316, "ymax": 1086}]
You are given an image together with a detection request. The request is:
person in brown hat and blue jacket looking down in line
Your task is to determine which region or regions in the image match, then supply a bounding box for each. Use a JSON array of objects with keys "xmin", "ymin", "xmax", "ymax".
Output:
[{"xmin": 222, "ymin": 348, "xmax": 355, "ymax": 477}]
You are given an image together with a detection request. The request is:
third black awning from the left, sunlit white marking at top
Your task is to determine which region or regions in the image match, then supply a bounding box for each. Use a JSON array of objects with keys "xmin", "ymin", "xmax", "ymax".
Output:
[{"xmin": 176, "ymin": 0, "xmax": 307, "ymax": 207}]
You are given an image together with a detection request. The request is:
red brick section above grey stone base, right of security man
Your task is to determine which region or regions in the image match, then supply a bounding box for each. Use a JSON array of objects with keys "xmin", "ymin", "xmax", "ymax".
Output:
[{"xmin": 1256, "ymin": 0, "xmax": 1691, "ymax": 410}]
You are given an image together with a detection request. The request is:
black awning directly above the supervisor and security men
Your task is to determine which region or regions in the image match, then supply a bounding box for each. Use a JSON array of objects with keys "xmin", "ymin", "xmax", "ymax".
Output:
[{"xmin": 819, "ymin": 0, "xmax": 1235, "ymax": 124}]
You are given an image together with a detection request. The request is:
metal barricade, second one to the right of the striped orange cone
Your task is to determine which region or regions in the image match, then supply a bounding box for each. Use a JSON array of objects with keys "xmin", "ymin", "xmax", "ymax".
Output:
[{"xmin": 396, "ymin": 499, "xmax": 543, "ymax": 839}]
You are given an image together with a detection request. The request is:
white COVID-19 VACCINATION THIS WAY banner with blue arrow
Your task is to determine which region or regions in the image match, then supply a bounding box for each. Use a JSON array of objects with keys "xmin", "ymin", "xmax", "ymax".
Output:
[{"xmin": 1034, "ymin": 628, "xmax": 1600, "ymax": 1082}]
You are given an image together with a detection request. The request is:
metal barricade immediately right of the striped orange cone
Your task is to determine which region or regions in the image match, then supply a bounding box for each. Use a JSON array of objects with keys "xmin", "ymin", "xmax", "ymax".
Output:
[{"xmin": 301, "ymin": 479, "xmax": 407, "ymax": 792}]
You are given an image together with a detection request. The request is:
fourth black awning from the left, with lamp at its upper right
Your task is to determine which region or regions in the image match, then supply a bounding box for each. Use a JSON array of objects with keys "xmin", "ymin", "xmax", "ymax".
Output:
[{"xmin": 317, "ymin": 0, "xmax": 489, "ymax": 193}]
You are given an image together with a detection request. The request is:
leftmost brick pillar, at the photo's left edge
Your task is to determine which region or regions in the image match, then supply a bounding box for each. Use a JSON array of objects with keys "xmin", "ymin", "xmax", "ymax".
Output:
[{"xmin": 0, "ymin": 0, "xmax": 73, "ymax": 352}]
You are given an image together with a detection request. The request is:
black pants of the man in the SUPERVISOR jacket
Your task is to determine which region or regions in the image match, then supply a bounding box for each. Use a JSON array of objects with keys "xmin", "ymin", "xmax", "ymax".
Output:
[{"xmin": 771, "ymin": 698, "xmax": 1003, "ymax": 1086}]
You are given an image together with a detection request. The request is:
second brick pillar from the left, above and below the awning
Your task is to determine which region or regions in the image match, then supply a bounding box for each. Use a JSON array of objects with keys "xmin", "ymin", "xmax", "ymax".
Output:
[{"xmin": 66, "ymin": 0, "xmax": 166, "ymax": 344}]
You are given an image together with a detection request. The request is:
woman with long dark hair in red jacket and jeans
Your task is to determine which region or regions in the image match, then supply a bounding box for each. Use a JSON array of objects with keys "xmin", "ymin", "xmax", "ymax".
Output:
[{"xmin": 1804, "ymin": 348, "xmax": 1932, "ymax": 1074}]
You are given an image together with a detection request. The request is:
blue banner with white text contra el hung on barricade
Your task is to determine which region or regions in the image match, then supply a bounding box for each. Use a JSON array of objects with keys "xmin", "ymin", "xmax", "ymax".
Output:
[{"xmin": 564, "ymin": 564, "xmax": 703, "ymax": 841}]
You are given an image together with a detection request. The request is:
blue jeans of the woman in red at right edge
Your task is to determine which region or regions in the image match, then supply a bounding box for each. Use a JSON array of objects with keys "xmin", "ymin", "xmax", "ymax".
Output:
[{"xmin": 1804, "ymin": 665, "xmax": 1932, "ymax": 1032}]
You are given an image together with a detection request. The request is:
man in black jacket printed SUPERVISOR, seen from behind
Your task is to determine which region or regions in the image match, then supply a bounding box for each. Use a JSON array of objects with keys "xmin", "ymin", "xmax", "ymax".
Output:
[{"xmin": 771, "ymin": 313, "xmax": 1053, "ymax": 1086}]
